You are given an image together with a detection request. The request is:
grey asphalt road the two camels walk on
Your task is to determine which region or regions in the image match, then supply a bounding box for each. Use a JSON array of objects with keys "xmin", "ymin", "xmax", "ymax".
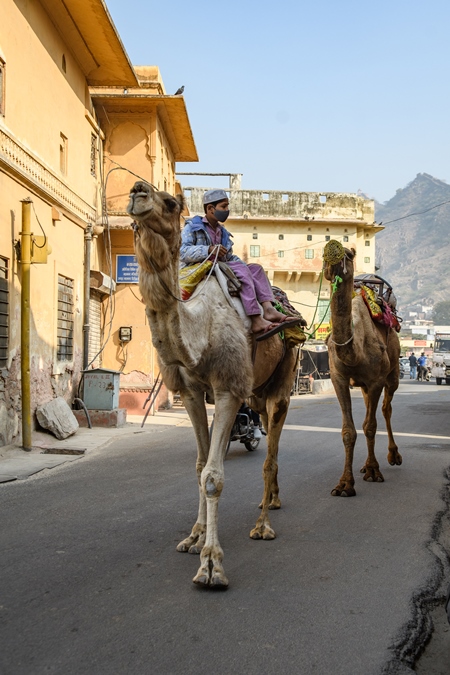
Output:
[{"xmin": 0, "ymin": 380, "xmax": 450, "ymax": 675}]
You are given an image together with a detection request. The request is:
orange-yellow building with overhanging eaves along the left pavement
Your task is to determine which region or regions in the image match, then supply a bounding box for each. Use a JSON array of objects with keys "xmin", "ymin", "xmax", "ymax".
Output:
[{"xmin": 0, "ymin": 0, "xmax": 197, "ymax": 445}]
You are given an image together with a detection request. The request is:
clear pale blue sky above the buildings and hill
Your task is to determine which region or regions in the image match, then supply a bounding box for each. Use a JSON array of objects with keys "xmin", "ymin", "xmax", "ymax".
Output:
[{"xmin": 106, "ymin": 0, "xmax": 450, "ymax": 202}]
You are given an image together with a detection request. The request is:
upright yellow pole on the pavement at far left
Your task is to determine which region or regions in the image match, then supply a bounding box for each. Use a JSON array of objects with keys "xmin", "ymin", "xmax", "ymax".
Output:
[{"xmin": 20, "ymin": 198, "xmax": 32, "ymax": 451}]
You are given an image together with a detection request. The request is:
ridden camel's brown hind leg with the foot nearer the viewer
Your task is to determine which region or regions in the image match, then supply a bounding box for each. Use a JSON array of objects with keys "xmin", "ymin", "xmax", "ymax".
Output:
[{"xmin": 250, "ymin": 397, "xmax": 289, "ymax": 539}]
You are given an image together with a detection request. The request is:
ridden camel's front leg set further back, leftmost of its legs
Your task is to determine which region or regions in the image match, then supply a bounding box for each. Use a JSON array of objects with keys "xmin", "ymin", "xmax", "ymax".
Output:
[{"xmin": 177, "ymin": 390, "xmax": 209, "ymax": 553}]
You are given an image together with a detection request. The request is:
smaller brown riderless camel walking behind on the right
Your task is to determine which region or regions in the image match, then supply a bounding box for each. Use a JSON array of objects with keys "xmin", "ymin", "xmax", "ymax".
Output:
[{"xmin": 324, "ymin": 240, "xmax": 402, "ymax": 497}]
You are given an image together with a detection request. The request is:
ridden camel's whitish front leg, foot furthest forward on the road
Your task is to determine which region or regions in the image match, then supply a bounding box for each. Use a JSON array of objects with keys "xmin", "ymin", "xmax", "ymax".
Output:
[{"xmin": 193, "ymin": 391, "xmax": 241, "ymax": 588}]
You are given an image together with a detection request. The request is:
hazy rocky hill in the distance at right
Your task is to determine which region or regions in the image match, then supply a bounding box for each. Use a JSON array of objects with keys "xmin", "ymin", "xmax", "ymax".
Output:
[{"xmin": 375, "ymin": 173, "xmax": 450, "ymax": 316}]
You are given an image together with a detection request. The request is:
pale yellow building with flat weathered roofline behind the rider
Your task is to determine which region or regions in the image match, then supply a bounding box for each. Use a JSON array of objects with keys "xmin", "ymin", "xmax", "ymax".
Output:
[{"xmin": 184, "ymin": 180, "xmax": 384, "ymax": 338}]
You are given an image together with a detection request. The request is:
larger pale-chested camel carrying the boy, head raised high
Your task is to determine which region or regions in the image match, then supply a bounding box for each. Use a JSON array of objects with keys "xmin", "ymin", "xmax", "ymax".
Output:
[{"xmin": 128, "ymin": 182, "xmax": 297, "ymax": 588}]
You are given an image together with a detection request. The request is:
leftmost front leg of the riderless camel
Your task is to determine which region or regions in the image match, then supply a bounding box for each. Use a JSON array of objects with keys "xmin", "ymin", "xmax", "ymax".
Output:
[{"xmin": 331, "ymin": 378, "xmax": 356, "ymax": 497}]
